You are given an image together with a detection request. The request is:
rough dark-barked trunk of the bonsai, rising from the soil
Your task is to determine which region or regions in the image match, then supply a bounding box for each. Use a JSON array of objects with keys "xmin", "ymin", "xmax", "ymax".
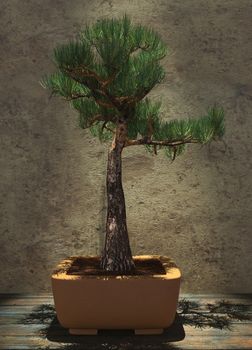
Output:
[{"xmin": 101, "ymin": 120, "xmax": 135, "ymax": 274}]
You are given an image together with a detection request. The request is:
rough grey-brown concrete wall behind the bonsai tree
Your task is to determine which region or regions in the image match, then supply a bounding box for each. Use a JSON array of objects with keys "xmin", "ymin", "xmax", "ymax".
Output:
[{"xmin": 0, "ymin": 0, "xmax": 252, "ymax": 293}]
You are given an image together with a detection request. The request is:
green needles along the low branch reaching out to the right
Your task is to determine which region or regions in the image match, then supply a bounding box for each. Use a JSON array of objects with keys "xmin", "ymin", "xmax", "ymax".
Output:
[{"xmin": 128, "ymin": 98, "xmax": 224, "ymax": 159}]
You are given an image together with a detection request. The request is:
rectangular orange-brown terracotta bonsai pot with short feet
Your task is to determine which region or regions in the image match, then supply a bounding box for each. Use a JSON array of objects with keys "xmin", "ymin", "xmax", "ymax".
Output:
[{"xmin": 51, "ymin": 255, "xmax": 181, "ymax": 335}]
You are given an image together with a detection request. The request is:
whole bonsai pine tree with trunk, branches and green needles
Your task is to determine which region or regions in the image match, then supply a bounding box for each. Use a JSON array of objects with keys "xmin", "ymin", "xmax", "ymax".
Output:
[{"xmin": 40, "ymin": 14, "xmax": 224, "ymax": 274}]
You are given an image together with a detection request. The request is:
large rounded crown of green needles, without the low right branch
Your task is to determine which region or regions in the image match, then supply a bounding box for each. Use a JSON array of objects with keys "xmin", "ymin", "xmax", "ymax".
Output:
[{"xmin": 40, "ymin": 14, "xmax": 167, "ymax": 139}]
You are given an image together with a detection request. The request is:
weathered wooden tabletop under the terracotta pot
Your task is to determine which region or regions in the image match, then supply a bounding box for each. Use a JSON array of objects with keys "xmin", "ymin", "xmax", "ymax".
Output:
[{"xmin": 0, "ymin": 294, "xmax": 252, "ymax": 350}]
